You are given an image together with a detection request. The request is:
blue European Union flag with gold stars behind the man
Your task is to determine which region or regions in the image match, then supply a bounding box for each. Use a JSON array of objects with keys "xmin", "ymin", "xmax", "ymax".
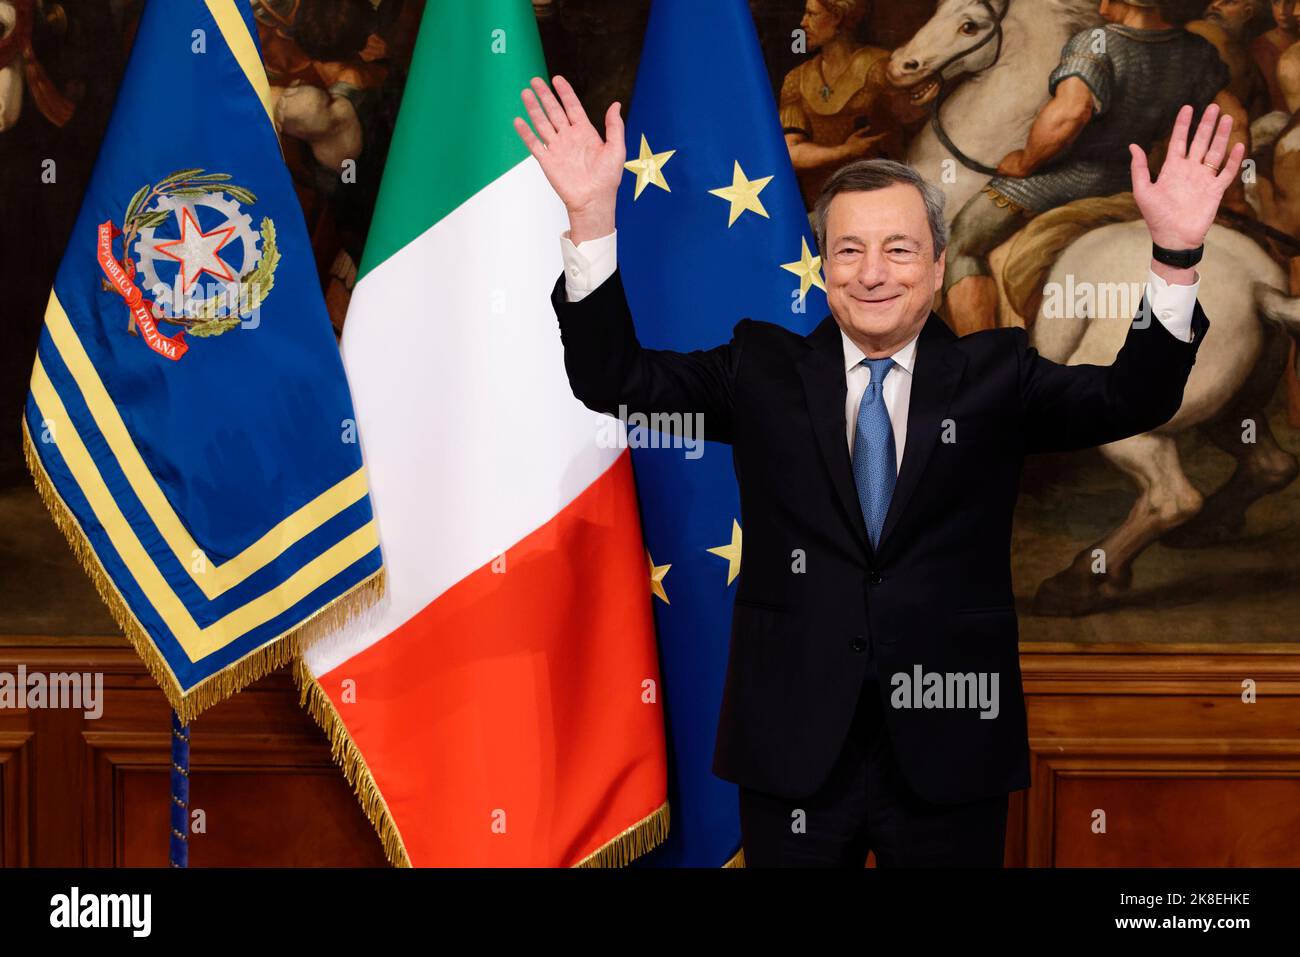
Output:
[{"xmin": 618, "ymin": 0, "xmax": 826, "ymax": 867}]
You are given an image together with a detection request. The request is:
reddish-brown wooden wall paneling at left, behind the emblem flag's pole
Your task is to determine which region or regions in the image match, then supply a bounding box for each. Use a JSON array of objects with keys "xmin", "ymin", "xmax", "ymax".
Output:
[{"xmin": 0, "ymin": 640, "xmax": 386, "ymax": 866}]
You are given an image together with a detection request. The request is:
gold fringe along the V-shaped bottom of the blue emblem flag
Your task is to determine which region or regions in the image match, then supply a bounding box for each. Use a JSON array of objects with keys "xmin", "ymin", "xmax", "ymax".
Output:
[{"xmin": 22, "ymin": 416, "xmax": 386, "ymax": 724}]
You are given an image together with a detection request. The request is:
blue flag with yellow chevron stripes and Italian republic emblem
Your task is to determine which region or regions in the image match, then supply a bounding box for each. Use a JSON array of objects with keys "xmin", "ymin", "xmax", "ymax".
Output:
[{"xmin": 23, "ymin": 0, "xmax": 382, "ymax": 720}]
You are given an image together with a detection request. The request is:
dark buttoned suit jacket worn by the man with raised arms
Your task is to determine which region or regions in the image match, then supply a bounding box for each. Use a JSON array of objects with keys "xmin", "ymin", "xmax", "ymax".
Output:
[{"xmin": 551, "ymin": 272, "xmax": 1209, "ymax": 804}]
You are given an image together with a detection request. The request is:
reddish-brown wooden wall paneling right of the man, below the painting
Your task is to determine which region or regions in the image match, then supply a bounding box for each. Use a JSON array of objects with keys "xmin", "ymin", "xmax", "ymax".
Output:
[{"xmin": 1009, "ymin": 646, "xmax": 1300, "ymax": 867}]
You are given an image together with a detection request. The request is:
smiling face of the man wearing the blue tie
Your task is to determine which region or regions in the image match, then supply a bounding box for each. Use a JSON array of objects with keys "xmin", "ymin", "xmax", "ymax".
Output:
[{"xmin": 826, "ymin": 183, "xmax": 946, "ymax": 358}]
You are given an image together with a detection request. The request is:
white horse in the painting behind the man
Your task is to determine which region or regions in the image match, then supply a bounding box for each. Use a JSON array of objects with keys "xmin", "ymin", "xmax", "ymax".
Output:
[{"xmin": 889, "ymin": 0, "xmax": 1297, "ymax": 615}]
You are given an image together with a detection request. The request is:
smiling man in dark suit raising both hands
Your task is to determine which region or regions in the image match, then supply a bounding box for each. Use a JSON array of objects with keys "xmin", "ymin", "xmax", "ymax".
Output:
[{"xmin": 515, "ymin": 77, "xmax": 1243, "ymax": 867}]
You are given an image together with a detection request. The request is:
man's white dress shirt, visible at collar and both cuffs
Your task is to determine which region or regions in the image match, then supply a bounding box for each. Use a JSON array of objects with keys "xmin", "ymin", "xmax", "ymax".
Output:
[{"xmin": 560, "ymin": 230, "xmax": 1201, "ymax": 472}]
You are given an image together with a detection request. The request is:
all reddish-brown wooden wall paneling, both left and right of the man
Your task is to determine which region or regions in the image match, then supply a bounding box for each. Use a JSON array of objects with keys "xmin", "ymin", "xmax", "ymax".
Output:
[{"xmin": 0, "ymin": 637, "xmax": 1300, "ymax": 867}]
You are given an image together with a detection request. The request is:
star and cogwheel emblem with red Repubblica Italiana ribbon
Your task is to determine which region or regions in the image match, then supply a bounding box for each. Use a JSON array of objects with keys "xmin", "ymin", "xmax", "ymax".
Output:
[{"xmin": 96, "ymin": 169, "xmax": 280, "ymax": 360}]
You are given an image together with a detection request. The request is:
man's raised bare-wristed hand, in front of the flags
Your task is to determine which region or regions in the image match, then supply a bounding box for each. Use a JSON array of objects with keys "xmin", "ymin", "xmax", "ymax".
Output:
[{"xmin": 515, "ymin": 75, "xmax": 628, "ymax": 244}]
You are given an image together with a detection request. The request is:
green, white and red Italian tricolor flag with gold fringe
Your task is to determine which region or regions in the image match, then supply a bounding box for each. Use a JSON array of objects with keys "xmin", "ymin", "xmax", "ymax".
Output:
[{"xmin": 298, "ymin": 0, "xmax": 668, "ymax": 866}]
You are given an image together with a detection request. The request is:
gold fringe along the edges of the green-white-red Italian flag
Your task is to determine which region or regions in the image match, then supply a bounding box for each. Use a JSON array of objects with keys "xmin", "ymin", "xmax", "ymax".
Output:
[{"xmin": 294, "ymin": 650, "xmax": 668, "ymax": 867}]
